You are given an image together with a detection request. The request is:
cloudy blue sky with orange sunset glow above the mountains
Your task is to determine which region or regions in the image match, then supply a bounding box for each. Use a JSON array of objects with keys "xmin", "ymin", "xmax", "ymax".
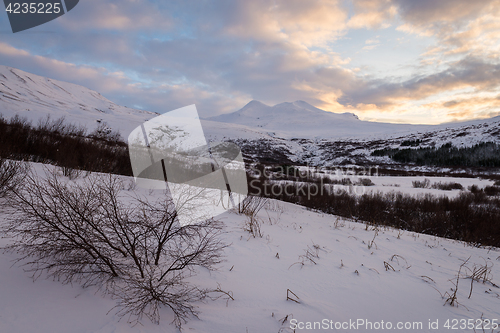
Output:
[{"xmin": 0, "ymin": 0, "xmax": 500, "ymax": 124}]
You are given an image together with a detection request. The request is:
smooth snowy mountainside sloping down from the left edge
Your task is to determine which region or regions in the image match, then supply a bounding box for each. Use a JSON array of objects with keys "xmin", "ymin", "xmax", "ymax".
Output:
[{"xmin": 0, "ymin": 66, "xmax": 157, "ymax": 137}]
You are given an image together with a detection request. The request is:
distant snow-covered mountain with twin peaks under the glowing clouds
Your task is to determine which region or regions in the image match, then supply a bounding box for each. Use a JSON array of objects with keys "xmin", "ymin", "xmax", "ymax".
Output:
[{"xmin": 207, "ymin": 100, "xmax": 500, "ymax": 139}]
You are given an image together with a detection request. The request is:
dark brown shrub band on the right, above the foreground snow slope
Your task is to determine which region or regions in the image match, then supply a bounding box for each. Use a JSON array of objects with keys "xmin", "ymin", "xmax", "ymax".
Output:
[{"xmin": 248, "ymin": 166, "xmax": 500, "ymax": 247}]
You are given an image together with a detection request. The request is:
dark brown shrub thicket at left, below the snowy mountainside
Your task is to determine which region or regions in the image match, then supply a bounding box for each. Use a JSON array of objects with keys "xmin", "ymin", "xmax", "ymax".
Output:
[{"xmin": 0, "ymin": 116, "xmax": 132, "ymax": 176}]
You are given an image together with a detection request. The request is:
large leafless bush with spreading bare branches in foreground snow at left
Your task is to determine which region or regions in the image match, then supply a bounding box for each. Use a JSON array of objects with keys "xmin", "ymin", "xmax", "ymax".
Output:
[{"xmin": 3, "ymin": 172, "xmax": 225, "ymax": 327}]
